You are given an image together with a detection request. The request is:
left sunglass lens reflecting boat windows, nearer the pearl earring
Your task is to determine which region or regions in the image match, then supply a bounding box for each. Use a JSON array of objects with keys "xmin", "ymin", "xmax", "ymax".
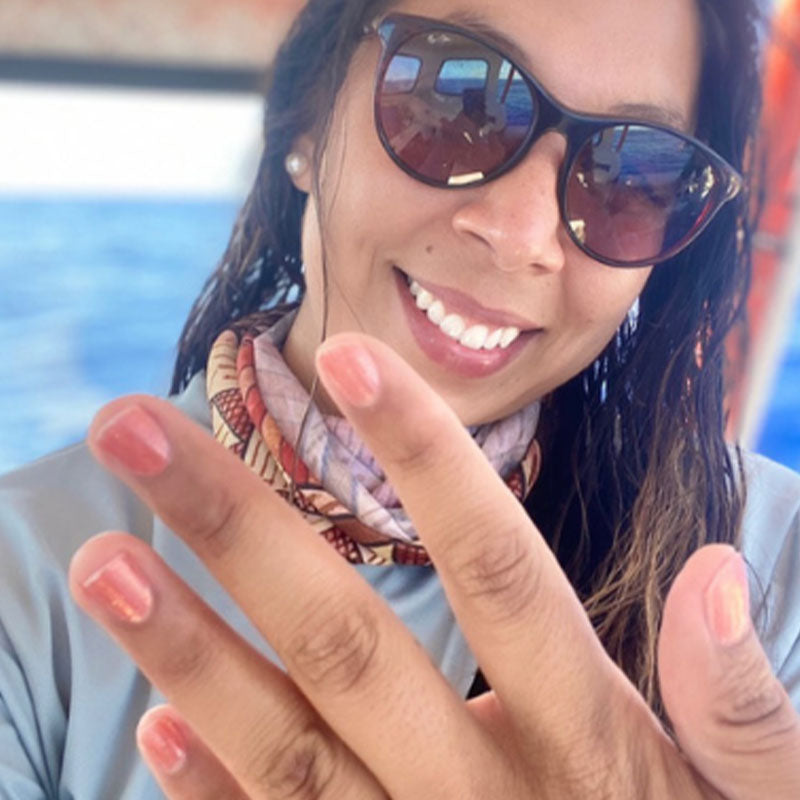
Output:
[{"xmin": 376, "ymin": 31, "xmax": 536, "ymax": 186}]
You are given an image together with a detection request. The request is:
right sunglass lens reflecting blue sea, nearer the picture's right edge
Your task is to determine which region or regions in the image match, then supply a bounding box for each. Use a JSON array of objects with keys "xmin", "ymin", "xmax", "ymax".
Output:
[{"xmin": 566, "ymin": 125, "xmax": 722, "ymax": 264}]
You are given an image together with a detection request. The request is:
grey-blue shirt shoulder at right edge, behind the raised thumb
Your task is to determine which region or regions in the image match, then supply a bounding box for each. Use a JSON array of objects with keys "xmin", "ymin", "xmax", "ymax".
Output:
[{"xmin": 741, "ymin": 453, "xmax": 800, "ymax": 709}]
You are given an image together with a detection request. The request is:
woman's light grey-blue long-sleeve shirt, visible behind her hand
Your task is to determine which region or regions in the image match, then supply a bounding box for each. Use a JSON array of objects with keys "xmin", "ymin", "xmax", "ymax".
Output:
[{"xmin": 0, "ymin": 375, "xmax": 800, "ymax": 800}]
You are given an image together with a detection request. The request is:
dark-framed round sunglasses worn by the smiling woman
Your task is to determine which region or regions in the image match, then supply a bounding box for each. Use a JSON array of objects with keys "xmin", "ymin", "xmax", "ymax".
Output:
[{"xmin": 371, "ymin": 14, "xmax": 742, "ymax": 267}]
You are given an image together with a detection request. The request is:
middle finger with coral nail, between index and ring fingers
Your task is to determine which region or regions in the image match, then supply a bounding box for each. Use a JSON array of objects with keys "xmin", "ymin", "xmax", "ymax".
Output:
[{"xmin": 89, "ymin": 397, "xmax": 505, "ymax": 798}]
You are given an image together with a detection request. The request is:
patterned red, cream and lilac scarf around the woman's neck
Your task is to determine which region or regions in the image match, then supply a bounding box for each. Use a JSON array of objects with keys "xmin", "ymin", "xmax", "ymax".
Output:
[{"xmin": 206, "ymin": 308, "xmax": 541, "ymax": 566}]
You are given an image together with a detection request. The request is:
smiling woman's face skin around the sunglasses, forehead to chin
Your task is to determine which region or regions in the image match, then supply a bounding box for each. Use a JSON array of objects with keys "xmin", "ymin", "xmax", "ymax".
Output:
[{"xmin": 285, "ymin": 0, "xmax": 701, "ymax": 425}]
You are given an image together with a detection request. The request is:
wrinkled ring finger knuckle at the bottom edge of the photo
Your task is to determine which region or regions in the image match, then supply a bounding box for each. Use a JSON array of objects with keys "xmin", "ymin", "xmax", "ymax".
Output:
[{"xmin": 245, "ymin": 724, "xmax": 338, "ymax": 800}]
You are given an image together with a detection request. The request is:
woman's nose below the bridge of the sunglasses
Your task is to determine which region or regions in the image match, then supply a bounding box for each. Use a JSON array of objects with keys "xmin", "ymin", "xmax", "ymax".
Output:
[{"xmin": 452, "ymin": 132, "xmax": 566, "ymax": 272}]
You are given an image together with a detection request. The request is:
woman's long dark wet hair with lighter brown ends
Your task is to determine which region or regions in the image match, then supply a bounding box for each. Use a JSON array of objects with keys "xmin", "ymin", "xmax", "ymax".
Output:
[{"xmin": 172, "ymin": 0, "xmax": 760, "ymax": 714}]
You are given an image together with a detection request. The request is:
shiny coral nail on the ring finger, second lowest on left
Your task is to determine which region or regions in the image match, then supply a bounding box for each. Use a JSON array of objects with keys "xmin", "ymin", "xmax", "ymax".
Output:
[{"xmin": 81, "ymin": 552, "xmax": 153, "ymax": 624}]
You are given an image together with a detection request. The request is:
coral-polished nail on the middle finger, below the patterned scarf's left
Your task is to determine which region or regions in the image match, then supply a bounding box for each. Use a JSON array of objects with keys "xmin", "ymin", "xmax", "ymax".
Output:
[{"xmin": 95, "ymin": 405, "xmax": 171, "ymax": 476}]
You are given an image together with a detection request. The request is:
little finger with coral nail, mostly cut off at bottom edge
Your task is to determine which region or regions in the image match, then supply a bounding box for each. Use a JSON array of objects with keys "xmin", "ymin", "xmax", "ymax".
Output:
[{"xmin": 136, "ymin": 706, "xmax": 247, "ymax": 800}]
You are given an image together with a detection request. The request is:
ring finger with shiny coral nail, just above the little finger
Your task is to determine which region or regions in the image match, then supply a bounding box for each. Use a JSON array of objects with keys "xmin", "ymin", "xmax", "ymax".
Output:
[{"xmin": 69, "ymin": 533, "xmax": 384, "ymax": 800}]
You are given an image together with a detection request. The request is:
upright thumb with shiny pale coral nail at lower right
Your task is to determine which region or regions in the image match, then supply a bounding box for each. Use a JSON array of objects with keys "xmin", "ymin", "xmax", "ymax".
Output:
[{"xmin": 658, "ymin": 545, "xmax": 800, "ymax": 800}]
